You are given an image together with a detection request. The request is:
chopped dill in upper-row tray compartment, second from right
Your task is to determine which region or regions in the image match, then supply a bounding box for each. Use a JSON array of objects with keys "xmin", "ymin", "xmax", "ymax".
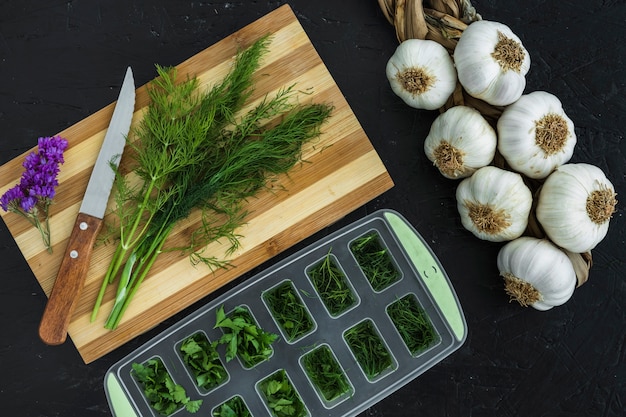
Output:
[{"xmin": 308, "ymin": 250, "xmax": 356, "ymax": 316}]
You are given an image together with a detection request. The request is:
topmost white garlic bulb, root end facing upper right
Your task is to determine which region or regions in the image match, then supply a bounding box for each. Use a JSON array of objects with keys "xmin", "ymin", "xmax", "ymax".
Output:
[{"xmin": 454, "ymin": 20, "xmax": 530, "ymax": 106}]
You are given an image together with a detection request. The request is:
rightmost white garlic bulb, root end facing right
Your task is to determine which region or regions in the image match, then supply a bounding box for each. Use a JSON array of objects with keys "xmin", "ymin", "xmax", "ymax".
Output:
[{"xmin": 536, "ymin": 163, "xmax": 617, "ymax": 253}]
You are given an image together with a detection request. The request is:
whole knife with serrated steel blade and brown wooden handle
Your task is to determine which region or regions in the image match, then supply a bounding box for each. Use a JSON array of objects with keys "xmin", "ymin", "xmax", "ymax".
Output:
[{"xmin": 39, "ymin": 67, "xmax": 135, "ymax": 345}]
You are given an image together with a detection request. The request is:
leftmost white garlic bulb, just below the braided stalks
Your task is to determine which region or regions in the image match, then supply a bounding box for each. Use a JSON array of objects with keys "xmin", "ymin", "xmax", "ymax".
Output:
[{"xmin": 386, "ymin": 39, "xmax": 457, "ymax": 110}]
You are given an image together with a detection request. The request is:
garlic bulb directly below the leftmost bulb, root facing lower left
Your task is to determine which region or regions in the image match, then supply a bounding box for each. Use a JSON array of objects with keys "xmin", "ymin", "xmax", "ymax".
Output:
[{"xmin": 424, "ymin": 106, "xmax": 497, "ymax": 179}]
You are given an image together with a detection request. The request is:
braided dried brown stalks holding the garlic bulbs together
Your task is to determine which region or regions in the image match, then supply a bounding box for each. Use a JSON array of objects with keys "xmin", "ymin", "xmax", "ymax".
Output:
[{"xmin": 378, "ymin": 0, "xmax": 593, "ymax": 286}]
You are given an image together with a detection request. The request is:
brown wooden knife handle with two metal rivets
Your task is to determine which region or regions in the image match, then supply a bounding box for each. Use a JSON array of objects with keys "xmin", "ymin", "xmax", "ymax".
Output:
[{"xmin": 39, "ymin": 213, "xmax": 103, "ymax": 345}]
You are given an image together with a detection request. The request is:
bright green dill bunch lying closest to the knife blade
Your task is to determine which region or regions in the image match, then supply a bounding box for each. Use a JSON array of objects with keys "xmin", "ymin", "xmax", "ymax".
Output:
[{"xmin": 91, "ymin": 35, "xmax": 270, "ymax": 321}]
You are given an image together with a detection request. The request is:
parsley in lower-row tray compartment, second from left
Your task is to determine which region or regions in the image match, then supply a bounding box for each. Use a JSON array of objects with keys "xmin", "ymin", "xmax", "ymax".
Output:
[{"xmin": 259, "ymin": 369, "xmax": 308, "ymax": 417}]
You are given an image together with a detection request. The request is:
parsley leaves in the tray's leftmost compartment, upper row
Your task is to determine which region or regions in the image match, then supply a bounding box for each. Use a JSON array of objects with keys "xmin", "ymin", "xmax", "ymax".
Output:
[{"xmin": 131, "ymin": 358, "xmax": 202, "ymax": 416}]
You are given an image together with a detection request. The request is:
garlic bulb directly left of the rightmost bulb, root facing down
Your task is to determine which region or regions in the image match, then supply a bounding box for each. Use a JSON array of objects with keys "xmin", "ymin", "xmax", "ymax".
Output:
[{"xmin": 456, "ymin": 166, "xmax": 532, "ymax": 242}]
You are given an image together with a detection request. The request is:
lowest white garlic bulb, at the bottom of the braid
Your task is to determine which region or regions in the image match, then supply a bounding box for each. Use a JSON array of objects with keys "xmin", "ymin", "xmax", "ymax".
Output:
[{"xmin": 497, "ymin": 236, "xmax": 577, "ymax": 311}]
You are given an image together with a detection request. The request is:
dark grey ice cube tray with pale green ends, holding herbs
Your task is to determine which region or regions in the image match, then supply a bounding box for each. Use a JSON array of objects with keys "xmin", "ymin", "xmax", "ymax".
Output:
[{"xmin": 105, "ymin": 209, "xmax": 467, "ymax": 417}]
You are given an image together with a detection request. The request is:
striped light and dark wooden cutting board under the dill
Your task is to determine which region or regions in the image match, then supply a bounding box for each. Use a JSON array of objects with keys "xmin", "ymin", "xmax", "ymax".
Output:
[{"xmin": 0, "ymin": 5, "xmax": 393, "ymax": 363}]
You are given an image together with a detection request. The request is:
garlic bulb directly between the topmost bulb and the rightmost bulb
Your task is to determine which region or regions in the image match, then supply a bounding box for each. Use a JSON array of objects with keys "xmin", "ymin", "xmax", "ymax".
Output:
[{"xmin": 497, "ymin": 91, "xmax": 576, "ymax": 179}]
